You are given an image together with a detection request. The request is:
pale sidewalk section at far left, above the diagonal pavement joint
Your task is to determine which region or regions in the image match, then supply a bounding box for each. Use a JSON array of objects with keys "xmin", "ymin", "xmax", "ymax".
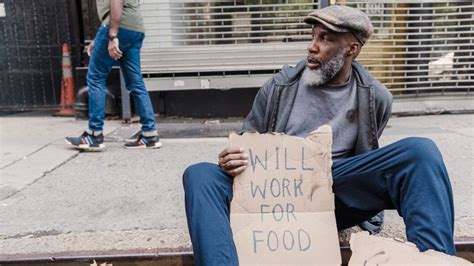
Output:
[{"xmin": 0, "ymin": 114, "xmax": 121, "ymax": 202}]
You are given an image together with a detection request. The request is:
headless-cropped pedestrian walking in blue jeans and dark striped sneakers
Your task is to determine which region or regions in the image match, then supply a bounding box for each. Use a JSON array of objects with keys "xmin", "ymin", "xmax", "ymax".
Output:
[{"xmin": 66, "ymin": 0, "xmax": 161, "ymax": 150}]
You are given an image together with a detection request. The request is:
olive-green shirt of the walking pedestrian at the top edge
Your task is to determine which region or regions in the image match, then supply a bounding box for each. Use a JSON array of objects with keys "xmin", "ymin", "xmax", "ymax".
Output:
[{"xmin": 96, "ymin": 0, "xmax": 145, "ymax": 33}]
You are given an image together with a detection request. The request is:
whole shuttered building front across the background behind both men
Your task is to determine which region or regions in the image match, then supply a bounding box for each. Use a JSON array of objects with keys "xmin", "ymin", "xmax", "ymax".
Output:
[{"xmin": 0, "ymin": 0, "xmax": 474, "ymax": 116}]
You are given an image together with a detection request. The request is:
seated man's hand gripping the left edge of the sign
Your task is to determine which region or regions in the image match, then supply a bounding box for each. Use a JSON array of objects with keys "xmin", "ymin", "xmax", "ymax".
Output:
[{"xmin": 219, "ymin": 147, "xmax": 248, "ymax": 176}]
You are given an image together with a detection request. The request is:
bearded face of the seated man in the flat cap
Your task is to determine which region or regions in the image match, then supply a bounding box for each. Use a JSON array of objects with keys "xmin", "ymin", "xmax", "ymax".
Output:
[{"xmin": 302, "ymin": 25, "xmax": 346, "ymax": 86}]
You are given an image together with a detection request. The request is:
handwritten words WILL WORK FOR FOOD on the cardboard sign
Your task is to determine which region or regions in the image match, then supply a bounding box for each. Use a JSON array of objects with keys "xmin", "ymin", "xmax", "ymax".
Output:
[{"xmin": 248, "ymin": 147, "xmax": 314, "ymax": 253}]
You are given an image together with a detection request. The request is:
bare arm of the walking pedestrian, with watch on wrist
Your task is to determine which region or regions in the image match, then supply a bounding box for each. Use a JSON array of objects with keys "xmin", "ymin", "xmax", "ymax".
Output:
[{"xmin": 109, "ymin": 0, "xmax": 123, "ymax": 60}]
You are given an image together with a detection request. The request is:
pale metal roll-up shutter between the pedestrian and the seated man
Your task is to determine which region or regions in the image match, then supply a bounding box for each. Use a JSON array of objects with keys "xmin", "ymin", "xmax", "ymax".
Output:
[{"xmin": 141, "ymin": 0, "xmax": 318, "ymax": 90}]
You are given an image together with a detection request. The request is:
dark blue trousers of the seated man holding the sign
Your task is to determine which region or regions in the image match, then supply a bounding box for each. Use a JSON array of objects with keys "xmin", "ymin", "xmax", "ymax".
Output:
[{"xmin": 183, "ymin": 138, "xmax": 455, "ymax": 265}]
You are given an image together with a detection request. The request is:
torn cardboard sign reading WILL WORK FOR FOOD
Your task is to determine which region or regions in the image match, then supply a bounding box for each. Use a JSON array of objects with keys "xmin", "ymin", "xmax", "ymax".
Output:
[{"xmin": 229, "ymin": 126, "xmax": 341, "ymax": 265}]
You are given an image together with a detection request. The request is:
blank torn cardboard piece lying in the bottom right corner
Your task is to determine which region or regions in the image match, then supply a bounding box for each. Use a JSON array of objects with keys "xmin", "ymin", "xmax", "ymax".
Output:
[{"xmin": 349, "ymin": 232, "xmax": 472, "ymax": 266}]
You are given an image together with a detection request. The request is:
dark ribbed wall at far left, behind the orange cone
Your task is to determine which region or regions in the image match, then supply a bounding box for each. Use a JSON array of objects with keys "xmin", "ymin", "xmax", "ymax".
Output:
[{"xmin": 0, "ymin": 0, "xmax": 82, "ymax": 111}]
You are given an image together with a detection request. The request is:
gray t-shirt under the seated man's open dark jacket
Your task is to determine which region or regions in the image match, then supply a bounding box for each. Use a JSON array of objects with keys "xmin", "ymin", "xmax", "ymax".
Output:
[{"xmin": 285, "ymin": 77, "xmax": 357, "ymax": 160}]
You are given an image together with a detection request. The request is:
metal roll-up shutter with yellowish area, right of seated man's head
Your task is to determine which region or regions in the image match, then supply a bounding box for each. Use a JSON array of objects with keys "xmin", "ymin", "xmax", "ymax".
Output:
[{"xmin": 335, "ymin": 0, "xmax": 474, "ymax": 96}]
